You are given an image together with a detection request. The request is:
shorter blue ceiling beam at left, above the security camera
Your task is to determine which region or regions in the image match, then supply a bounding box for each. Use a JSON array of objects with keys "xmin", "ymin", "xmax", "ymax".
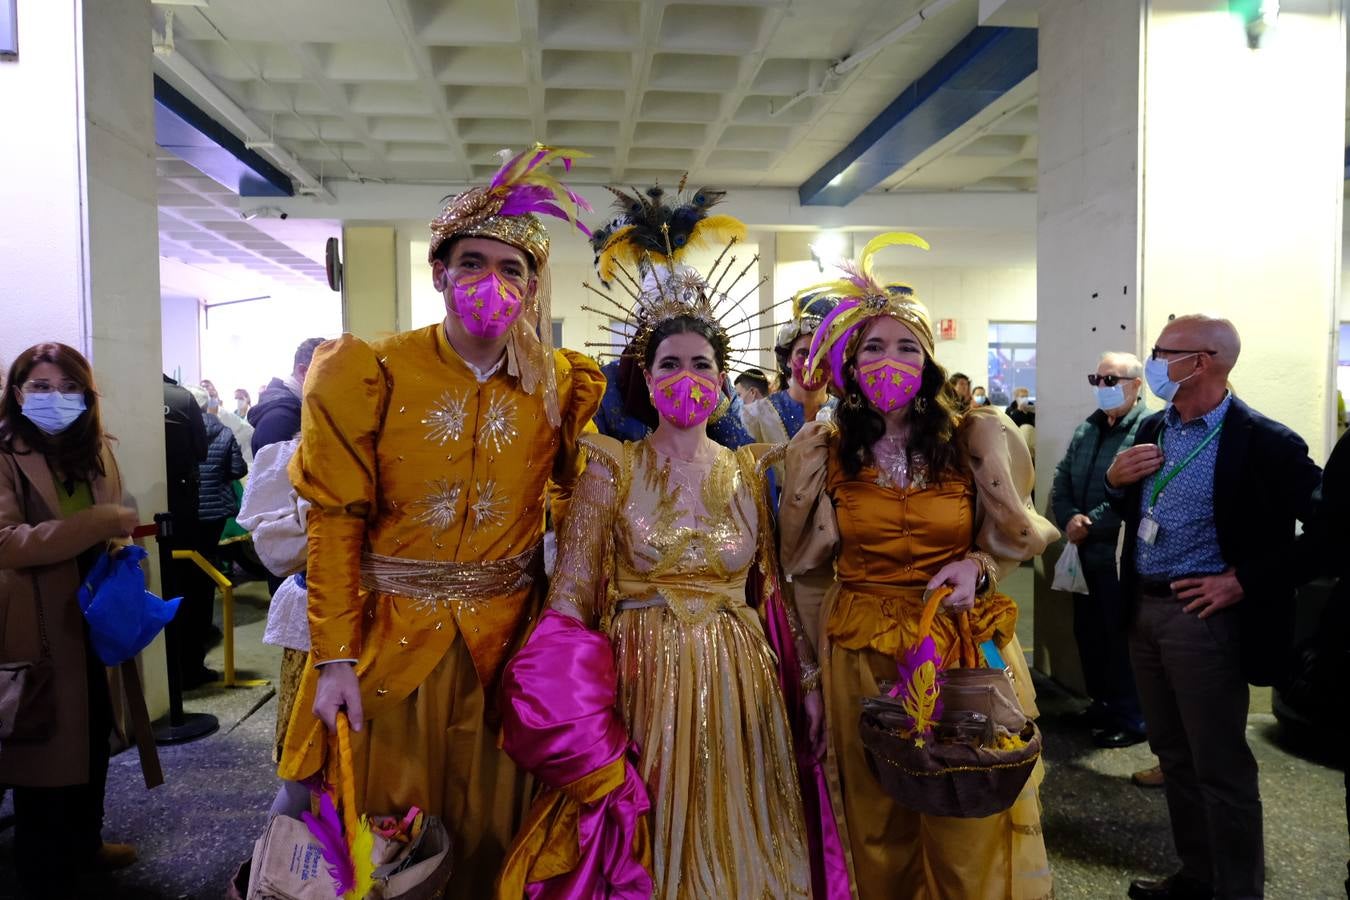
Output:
[{"xmin": 155, "ymin": 76, "xmax": 296, "ymax": 197}]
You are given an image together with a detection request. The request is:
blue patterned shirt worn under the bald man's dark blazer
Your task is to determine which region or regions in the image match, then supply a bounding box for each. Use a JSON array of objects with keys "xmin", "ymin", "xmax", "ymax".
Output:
[{"xmin": 1135, "ymin": 394, "xmax": 1233, "ymax": 579}]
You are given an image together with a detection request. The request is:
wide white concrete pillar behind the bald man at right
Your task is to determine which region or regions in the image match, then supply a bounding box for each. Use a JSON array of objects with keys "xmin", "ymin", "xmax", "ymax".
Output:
[{"xmin": 1035, "ymin": 0, "xmax": 1346, "ymax": 687}]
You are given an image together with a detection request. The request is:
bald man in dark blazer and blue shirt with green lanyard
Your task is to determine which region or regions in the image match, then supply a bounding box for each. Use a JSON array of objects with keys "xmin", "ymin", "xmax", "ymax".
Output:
[{"xmin": 1106, "ymin": 316, "xmax": 1320, "ymax": 900}]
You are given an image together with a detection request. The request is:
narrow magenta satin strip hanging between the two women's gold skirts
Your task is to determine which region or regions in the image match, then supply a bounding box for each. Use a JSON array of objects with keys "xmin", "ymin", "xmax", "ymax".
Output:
[{"xmin": 751, "ymin": 568, "xmax": 849, "ymax": 900}]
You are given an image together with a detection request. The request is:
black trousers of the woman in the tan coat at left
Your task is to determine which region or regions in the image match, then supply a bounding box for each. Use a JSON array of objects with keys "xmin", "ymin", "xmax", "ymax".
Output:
[{"xmin": 14, "ymin": 637, "xmax": 112, "ymax": 900}]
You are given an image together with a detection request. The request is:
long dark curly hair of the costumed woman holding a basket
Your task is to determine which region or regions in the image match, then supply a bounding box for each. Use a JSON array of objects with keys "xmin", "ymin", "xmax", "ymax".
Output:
[{"xmin": 834, "ymin": 356, "xmax": 965, "ymax": 482}]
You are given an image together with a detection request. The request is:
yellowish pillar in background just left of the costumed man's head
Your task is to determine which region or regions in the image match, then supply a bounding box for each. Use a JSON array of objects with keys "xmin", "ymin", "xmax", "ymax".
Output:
[{"xmin": 342, "ymin": 224, "xmax": 396, "ymax": 340}]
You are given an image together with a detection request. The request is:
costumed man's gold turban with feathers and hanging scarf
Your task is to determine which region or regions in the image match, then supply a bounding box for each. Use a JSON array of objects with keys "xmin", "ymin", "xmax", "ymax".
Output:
[{"xmin": 427, "ymin": 143, "xmax": 590, "ymax": 426}]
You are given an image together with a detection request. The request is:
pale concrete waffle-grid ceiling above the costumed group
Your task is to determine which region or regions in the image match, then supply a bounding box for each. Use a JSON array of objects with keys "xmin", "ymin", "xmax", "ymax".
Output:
[{"xmin": 157, "ymin": 0, "xmax": 1035, "ymax": 190}]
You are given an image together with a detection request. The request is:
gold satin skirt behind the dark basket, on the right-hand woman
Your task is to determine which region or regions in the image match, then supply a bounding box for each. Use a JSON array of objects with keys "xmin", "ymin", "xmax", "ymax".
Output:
[{"xmin": 821, "ymin": 638, "xmax": 1054, "ymax": 900}]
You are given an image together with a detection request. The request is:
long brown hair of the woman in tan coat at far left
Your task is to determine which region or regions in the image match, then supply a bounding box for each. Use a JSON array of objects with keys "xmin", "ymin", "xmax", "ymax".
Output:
[{"xmin": 0, "ymin": 341, "xmax": 107, "ymax": 480}]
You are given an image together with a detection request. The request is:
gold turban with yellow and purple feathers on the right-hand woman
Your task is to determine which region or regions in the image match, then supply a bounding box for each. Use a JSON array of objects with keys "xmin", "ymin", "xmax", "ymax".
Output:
[{"xmin": 806, "ymin": 231, "xmax": 933, "ymax": 390}]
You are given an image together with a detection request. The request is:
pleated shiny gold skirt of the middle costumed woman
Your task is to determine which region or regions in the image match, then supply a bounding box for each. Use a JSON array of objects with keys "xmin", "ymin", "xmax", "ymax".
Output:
[{"xmin": 610, "ymin": 606, "xmax": 811, "ymax": 900}]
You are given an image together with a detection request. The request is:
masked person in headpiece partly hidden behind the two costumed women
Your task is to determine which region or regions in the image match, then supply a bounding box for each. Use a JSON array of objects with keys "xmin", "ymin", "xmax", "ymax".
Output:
[{"xmin": 741, "ymin": 293, "xmax": 836, "ymax": 444}]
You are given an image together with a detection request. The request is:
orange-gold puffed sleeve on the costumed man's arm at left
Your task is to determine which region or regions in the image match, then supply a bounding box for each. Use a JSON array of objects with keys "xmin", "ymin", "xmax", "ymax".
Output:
[{"xmin": 290, "ymin": 335, "xmax": 389, "ymax": 664}]
